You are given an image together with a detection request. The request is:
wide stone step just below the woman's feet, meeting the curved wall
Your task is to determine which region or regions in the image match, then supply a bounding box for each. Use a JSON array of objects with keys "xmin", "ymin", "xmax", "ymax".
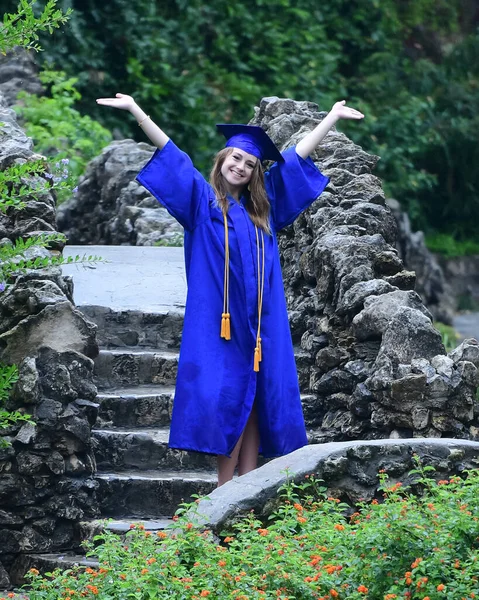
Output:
[{"xmin": 95, "ymin": 471, "xmax": 217, "ymax": 519}]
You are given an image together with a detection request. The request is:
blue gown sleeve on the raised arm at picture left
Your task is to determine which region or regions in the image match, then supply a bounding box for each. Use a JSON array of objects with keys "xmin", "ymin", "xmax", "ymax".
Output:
[{"xmin": 136, "ymin": 140, "xmax": 211, "ymax": 231}]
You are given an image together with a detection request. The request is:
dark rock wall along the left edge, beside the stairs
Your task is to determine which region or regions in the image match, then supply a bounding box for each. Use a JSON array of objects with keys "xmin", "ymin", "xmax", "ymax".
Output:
[{"xmin": 0, "ymin": 96, "xmax": 99, "ymax": 589}]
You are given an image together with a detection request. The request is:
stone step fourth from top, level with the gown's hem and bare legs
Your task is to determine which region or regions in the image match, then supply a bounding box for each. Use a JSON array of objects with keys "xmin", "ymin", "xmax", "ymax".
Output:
[{"xmin": 92, "ymin": 427, "xmax": 216, "ymax": 472}]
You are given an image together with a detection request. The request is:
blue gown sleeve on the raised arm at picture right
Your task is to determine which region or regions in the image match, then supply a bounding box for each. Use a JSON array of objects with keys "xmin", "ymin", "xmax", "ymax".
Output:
[{"xmin": 265, "ymin": 148, "xmax": 329, "ymax": 231}]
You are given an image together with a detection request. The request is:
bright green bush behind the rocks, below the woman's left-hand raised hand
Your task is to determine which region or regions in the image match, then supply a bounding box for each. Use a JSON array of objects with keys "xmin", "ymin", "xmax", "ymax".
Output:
[{"xmin": 15, "ymin": 71, "xmax": 112, "ymax": 195}]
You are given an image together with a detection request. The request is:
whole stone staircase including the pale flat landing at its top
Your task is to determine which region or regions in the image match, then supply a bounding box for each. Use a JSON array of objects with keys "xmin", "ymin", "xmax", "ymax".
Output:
[{"xmin": 7, "ymin": 247, "xmax": 320, "ymax": 578}]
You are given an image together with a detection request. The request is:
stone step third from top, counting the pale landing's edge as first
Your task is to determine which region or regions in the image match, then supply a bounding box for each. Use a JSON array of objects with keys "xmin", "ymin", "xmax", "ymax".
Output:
[{"xmin": 96, "ymin": 385, "xmax": 175, "ymax": 428}]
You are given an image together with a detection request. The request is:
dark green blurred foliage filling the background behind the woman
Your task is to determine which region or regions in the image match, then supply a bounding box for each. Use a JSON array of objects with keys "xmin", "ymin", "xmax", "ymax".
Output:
[{"xmin": 7, "ymin": 0, "xmax": 479, "ymax": 239}]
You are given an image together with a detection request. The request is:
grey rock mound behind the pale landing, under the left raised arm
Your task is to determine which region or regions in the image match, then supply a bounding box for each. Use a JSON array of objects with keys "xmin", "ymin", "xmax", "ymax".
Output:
[{"xmin": 57, "ymin": 140, "xmax": 183, "ymax": 246}]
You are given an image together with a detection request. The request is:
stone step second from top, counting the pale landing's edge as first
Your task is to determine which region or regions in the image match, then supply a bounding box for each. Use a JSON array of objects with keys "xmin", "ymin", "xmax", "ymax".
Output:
[{"xmin": 94, "ymin": 348, "xmax": 179, "ymax": 389}]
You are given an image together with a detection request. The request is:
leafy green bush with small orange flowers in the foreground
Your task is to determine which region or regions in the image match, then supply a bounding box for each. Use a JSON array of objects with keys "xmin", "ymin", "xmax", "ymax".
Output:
[{"xmin": 23, "ymin": 466, "xmax": 479, "ymax": 600}]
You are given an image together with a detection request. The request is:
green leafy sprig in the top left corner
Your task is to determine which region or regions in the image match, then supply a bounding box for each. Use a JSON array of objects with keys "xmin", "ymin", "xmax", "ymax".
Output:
[{"xmin": 0, "ymin": 0, "xmax": 71, "ymax": 54}]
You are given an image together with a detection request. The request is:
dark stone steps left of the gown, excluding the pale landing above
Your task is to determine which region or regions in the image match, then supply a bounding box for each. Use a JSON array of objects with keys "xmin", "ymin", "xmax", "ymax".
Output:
[{"xmin": 87, "ymin": 307, "xmax": 216, "ymax": 522}]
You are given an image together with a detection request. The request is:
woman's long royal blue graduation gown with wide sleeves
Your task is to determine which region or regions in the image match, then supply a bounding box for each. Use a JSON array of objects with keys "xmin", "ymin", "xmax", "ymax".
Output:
[{"xmin": 137, "ymin": 140, "xmax": 328, "ymax": 457}]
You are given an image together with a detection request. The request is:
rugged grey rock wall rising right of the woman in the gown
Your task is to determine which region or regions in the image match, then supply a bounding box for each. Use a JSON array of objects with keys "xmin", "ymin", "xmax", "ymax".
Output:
[{"xmin": 252, "ymin": 98, "xmax": 479, "ymax": 442}]
